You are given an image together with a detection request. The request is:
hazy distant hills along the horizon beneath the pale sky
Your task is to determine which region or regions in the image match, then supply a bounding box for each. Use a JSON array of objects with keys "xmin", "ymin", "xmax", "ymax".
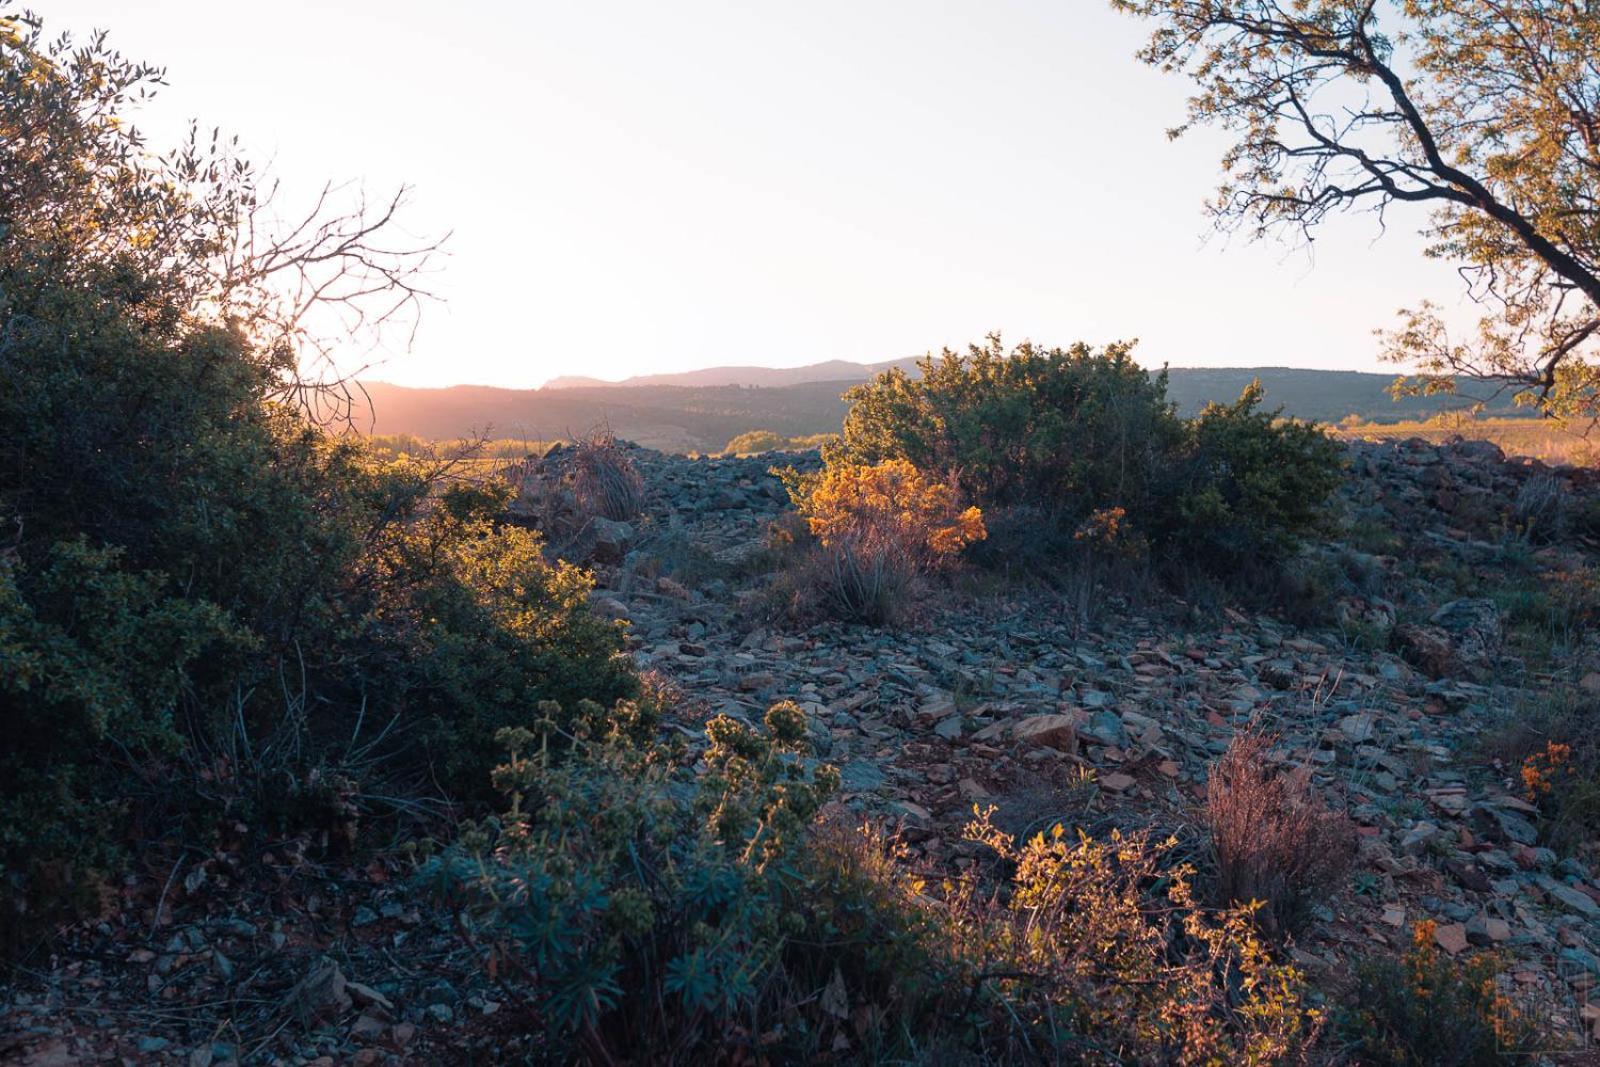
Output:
[{"xmin": 362, "ymin": 367, "xmax": 1514, "ymax": 451}]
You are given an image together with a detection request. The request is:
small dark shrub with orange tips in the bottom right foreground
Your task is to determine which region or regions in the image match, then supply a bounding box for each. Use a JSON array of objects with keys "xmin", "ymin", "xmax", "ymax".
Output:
[{"xmin": 1341, "ymin": 920, "xmax": 1550, "ymax": 1067}]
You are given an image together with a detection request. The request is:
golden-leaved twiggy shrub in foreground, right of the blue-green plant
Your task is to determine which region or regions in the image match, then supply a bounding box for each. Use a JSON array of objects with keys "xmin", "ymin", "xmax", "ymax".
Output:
[{"xmin": 944, "ymin": 809, "xmax": 1322, "ymax": 1064}]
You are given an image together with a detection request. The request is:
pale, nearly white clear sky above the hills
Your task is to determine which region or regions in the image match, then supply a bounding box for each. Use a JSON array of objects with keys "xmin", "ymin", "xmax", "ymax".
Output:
[{"xmin": 45, "ymin": 0, "xmax": 1459, "ymax": 387}]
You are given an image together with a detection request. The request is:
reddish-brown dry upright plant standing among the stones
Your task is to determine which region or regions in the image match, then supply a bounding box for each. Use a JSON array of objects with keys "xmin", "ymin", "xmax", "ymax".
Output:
[{"xmin": 1205, "ymin": 729, "xmax": 1355, "ymax": 933}]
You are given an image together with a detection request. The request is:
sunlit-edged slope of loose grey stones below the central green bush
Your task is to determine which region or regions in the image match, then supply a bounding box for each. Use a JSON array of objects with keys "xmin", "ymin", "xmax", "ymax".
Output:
[{"xmin": 582, "ymin": 442, "xmax": 1600, "ymax": 1055}]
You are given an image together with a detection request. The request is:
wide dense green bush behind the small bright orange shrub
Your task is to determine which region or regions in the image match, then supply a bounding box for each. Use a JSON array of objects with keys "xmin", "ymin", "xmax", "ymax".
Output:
[{"xmin": 824, "ymin": 338, "xmax": 1339, "ymax": 573}]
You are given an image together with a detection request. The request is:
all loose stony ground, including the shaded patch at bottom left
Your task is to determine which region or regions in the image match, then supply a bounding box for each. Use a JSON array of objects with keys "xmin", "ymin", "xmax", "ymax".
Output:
[{"xmin": 9, "ymin": 442, "xmax": 1600, "ymax": 1067}]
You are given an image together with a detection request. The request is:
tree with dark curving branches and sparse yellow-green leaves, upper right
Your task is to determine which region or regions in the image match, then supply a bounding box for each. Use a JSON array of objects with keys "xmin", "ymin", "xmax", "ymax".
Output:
[{"xmin": 1112, "ymin": 0, "xmax": 1600, "ymax": 416}]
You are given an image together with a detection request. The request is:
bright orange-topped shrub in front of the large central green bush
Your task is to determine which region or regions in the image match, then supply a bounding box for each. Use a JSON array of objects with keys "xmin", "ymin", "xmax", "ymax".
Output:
[{"xmin": 781, "ymin": 459, "xmax": 987, "ymax": 622}]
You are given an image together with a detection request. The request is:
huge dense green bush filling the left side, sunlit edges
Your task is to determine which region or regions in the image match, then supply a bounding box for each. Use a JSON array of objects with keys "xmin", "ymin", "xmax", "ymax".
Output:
[{"xmin": 0, "ymin": 10, "xmax": 637, "ymax": 934}]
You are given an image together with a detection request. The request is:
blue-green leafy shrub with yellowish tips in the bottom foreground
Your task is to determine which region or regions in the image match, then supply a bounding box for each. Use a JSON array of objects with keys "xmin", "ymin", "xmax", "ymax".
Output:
[{"xmin": 421, "ymin": 704, "xmax": 838, "ymax": 1062}]
